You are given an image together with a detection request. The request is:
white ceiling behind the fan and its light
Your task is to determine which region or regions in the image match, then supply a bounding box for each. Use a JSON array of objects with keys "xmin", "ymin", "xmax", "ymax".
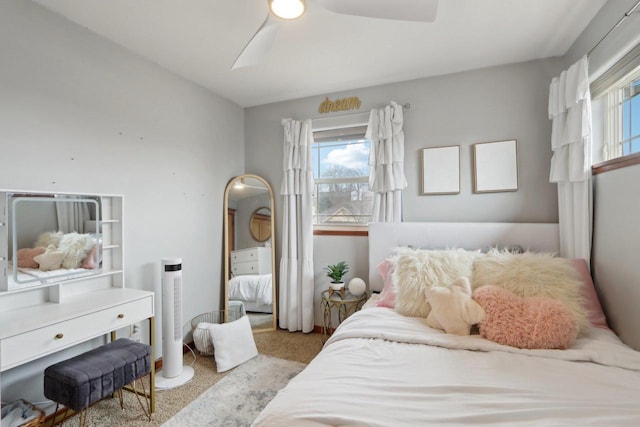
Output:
[{"xmin": 33, "ymin": 0, "xmax": 606, "ymax": 107}]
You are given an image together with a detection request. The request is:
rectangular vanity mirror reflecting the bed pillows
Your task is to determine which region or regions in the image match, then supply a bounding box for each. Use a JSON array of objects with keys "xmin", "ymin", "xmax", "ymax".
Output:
[{"xmin": 0, "ymin": 192, "xmax": 101, "ymax": 291}]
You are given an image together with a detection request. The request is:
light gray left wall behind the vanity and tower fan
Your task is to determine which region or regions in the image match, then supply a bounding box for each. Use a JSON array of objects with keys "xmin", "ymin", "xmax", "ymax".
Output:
[{"xmin": 0, "ymin": 0, "xmax": 244, "ymax": 401}]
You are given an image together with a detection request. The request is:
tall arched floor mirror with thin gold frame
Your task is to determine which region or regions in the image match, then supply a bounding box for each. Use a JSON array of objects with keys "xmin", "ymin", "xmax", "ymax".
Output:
[{"xmin": 224, "ymin": 175, "xmax": 277, "ymax": 332}]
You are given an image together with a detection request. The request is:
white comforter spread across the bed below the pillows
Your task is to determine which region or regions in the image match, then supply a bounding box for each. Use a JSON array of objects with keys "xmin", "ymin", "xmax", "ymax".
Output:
[{"xmin": 254, "ymin": 308, "xmax": 640, "ymax": 426}]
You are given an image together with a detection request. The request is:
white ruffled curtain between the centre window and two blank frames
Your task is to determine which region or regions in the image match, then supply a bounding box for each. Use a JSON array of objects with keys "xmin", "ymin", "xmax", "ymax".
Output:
[{"xmin": 366, "ymin": 101, "xmax": 407, "ymax": 222}]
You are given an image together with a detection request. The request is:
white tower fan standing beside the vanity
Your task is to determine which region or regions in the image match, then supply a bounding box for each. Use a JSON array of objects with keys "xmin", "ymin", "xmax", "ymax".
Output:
[{"xmin": 155, "ymin": 258, "xmax": 194, "ymax": 389}]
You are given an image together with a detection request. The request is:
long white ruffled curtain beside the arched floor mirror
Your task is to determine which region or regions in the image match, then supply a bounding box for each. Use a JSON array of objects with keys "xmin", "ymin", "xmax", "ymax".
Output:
[{"xmin": 279, "ymin": 119, "xmax": 314, "ymax": 332}]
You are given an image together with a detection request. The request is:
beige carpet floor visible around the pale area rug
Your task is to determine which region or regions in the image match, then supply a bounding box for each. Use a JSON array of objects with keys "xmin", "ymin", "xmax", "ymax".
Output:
[{"xmin": 65, "ymin": 330, "xmax": 322, "ymax": 427}]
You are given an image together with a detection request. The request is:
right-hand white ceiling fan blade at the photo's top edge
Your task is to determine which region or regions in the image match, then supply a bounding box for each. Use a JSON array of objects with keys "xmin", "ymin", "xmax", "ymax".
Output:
[{"xmin": 317, "ymin": 0, "xmax": 438, "ymax": 22}]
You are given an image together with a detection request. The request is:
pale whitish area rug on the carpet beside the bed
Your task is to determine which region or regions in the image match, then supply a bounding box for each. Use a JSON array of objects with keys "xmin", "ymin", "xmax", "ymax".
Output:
[{"xmin": 162, "ymin": 354, "xmax": 306, "ymax": 427}]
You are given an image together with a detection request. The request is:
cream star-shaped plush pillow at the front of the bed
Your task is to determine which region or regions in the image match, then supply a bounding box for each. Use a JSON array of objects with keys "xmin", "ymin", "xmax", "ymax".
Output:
[{"xmin": 425, "ymin": 277, "xmax": 485, "ymax": 335}]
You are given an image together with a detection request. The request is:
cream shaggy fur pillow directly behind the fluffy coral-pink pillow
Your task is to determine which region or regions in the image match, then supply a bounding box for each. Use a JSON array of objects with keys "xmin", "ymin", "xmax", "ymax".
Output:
[{"xmin": 471, "ymin": 250, "xmax": 590, "ymax": 334}]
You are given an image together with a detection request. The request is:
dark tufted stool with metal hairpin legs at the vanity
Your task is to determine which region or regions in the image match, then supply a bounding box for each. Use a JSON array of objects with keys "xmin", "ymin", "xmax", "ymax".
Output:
[{"xmin": 44, "ymin": 338, "xmax": 152, "ymax": 425}]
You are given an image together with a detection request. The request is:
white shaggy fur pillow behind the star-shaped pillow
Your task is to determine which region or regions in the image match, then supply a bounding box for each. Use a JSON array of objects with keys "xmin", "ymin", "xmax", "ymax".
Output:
[{"xmin": 392, "ymin": 248, "xmax": 482, "ymax": 317}]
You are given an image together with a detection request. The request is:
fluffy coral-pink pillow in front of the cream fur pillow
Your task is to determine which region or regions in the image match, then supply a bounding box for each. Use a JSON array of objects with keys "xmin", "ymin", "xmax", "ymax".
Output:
[{"xmin": 473, "ymin": 285, "xmax": 578, "ymax": 349}]
